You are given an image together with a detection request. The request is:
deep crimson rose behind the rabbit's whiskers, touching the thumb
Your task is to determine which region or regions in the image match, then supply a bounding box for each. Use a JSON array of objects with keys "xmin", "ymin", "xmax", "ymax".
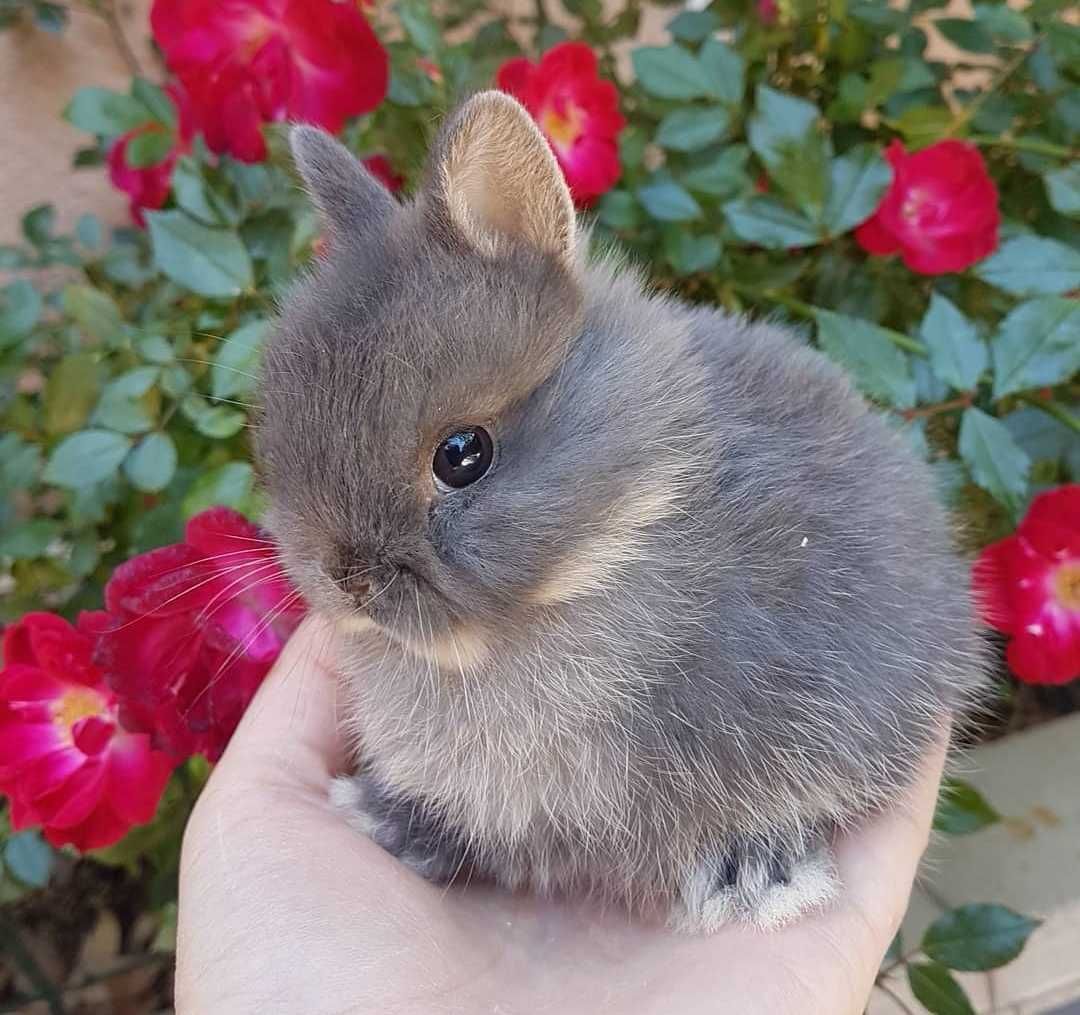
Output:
[{"xmin": 87, "ymin": 508, "xmax": 305, "ymax": 761}]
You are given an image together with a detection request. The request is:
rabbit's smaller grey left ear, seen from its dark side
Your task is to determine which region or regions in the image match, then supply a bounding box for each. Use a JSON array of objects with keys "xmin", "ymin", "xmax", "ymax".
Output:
[{"xmin": 288, "ymin": 125, "xmax": 396, "ymax": 234}]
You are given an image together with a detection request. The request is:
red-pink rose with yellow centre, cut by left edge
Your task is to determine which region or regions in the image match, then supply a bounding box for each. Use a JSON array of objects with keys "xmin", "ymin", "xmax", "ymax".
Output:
[{"xmin": 0, "ymin": 613, "xmax": 173, "ymax": 850}]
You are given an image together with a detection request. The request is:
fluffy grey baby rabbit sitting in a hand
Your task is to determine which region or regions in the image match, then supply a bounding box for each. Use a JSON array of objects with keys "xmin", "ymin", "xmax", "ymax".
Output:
[{"xmin": 257, "ymin": 92, "xmax": 980, "ymax": 932}]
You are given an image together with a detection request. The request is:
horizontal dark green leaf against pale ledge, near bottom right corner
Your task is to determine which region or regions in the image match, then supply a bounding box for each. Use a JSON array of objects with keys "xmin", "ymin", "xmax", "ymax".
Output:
[{"xmin": 922, "ymin": 903, "xmax": 1039, "ymax": 972}]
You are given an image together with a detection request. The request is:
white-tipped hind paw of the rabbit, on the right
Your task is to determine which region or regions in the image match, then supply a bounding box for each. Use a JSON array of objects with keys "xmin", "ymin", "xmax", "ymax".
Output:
[{"xmin": 669, "ymin": 836, "xmax": 839, "ymax": 934}]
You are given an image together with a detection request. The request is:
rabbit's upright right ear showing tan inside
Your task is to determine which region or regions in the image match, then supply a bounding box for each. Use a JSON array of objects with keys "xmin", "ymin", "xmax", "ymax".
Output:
[{"xmin": 427, "ymin": 92, "xmax": 575, "ymax": 269}]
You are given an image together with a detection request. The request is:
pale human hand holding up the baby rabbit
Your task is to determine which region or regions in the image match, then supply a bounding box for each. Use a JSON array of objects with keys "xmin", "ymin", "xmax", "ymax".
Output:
[{"xmin": 176, "ymin": 620, "xmax": 944, "ymax": 1015}]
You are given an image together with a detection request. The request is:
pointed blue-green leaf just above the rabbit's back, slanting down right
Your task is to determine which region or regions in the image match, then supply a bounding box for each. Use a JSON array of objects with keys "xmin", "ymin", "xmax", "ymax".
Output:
[{"xmin": 814, "ymin": 310, "xmax": 915, "ymax": 409}]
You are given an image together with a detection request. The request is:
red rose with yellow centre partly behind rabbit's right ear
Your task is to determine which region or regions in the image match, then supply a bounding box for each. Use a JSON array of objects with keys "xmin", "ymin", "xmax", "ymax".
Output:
[{"xmin": 496, "ymin": 42, "xmax": 626, "ymax": 206}]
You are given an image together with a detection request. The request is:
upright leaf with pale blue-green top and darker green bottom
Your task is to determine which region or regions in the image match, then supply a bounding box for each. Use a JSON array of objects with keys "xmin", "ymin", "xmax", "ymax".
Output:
[{"xmin": 747, "ymin": 84, "xmax": 828, "ymax": 219}]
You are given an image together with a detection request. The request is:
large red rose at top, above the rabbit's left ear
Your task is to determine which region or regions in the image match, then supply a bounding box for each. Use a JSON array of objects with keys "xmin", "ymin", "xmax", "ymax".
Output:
[{"xmin": 150, "ymin": 0, "xmax": 389, "ymax": 162}]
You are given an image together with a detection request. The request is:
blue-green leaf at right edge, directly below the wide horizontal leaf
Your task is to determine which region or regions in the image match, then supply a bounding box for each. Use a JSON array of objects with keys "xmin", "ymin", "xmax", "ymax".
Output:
[{"xmin": 991, "ymin": 296, "xmax": 1080, "ymax": 398}]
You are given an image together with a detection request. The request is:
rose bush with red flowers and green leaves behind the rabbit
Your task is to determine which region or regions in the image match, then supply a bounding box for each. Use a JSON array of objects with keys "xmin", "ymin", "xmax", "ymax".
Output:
[{"xmin": 0, "ymin": 0, "xmax": 1080, "ymax": 1011}]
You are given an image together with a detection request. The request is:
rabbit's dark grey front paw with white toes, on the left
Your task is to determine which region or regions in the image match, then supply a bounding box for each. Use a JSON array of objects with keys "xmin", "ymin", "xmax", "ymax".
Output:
[{"xmin": 330, "ymin": 773, "xmax": 474, "ymax": 884}]
